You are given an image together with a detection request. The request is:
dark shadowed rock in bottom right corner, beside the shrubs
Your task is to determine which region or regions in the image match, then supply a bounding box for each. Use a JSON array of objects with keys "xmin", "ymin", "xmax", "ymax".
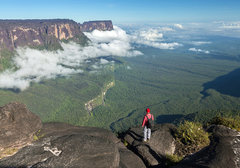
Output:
[{"xmin": 174, "ymin": 125, "xmax": 240, "ymax": 168}]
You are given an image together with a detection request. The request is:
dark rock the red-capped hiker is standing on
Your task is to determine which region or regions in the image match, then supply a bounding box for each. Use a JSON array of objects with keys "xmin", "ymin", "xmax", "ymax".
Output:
[{"xmin": 123, "ymin": 124, "xmax": 175, "ymax": 166}]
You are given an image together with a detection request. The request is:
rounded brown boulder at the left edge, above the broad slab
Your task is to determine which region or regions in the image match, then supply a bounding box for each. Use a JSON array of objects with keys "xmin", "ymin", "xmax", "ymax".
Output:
[{"xmin": 0, "ymin": 102, "xmax": 42, "ymax": 157}]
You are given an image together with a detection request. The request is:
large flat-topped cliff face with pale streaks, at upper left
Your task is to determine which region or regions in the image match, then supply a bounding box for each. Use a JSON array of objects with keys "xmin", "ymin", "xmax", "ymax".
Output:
[{"xmin": 0, "ymin": 19, "xmax": 87, "ymax": 50}]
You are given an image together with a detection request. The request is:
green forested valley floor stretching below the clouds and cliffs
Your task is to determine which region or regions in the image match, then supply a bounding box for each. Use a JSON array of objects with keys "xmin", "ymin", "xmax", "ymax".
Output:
[{"xmin": 0, "ymin": 37, "xmax": 240, "ymax": 132}]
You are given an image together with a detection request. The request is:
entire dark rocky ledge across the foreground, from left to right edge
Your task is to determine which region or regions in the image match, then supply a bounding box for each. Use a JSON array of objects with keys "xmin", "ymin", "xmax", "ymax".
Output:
[{"xmin": 0, "ymin": 103, "xmax": 240, "ymax": 168}]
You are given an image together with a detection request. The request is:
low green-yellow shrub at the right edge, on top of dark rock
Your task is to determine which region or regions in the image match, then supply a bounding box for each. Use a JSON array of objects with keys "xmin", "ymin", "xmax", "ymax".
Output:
[{"xmin": 208, "ymin": 116, "xmax": 240, "ymax": 131}]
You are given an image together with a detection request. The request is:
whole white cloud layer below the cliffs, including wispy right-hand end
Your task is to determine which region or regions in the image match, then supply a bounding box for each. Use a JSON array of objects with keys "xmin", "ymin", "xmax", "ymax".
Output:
[{"xmin": 0, "ymin": 24, "xmax": 188, "ymax": 91}]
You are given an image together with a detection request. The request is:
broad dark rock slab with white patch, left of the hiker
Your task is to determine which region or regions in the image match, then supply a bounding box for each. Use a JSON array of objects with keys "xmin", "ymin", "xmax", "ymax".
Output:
[{"xmin": 0, "ymin": 123, "xmax": 145, "ymax": 168}]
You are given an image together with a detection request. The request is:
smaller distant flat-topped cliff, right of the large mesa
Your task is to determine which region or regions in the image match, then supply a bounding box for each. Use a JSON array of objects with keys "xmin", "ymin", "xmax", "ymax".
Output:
[{"xmin": 80, "ymin": 20, "xmax": 113, "ymax": 32}]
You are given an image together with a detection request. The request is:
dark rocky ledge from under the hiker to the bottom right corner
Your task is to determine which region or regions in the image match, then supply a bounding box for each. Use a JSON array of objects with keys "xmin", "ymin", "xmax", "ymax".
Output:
[{"xmin": 122, "ymin": 124, "xmax": 240, "ymax": 168}]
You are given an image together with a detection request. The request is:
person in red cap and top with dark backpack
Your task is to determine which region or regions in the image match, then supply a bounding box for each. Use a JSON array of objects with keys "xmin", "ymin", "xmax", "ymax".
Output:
[{"xmin": 142, "ymin": 108, "xmax": 154, "ymax": 142}]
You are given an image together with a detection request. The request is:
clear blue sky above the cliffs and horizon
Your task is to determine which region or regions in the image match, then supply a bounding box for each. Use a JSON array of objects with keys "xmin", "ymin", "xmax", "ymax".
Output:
[{"xmin": 0, "ymin": 0, "xmax": 240, "ymax": 23}]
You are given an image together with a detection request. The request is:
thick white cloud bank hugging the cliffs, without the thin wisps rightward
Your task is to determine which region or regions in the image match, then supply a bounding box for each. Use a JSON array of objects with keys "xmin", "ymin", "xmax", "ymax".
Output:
[{"xmin": 0, "ymin": 27, "xmax": 142, "ymax": 90}]
